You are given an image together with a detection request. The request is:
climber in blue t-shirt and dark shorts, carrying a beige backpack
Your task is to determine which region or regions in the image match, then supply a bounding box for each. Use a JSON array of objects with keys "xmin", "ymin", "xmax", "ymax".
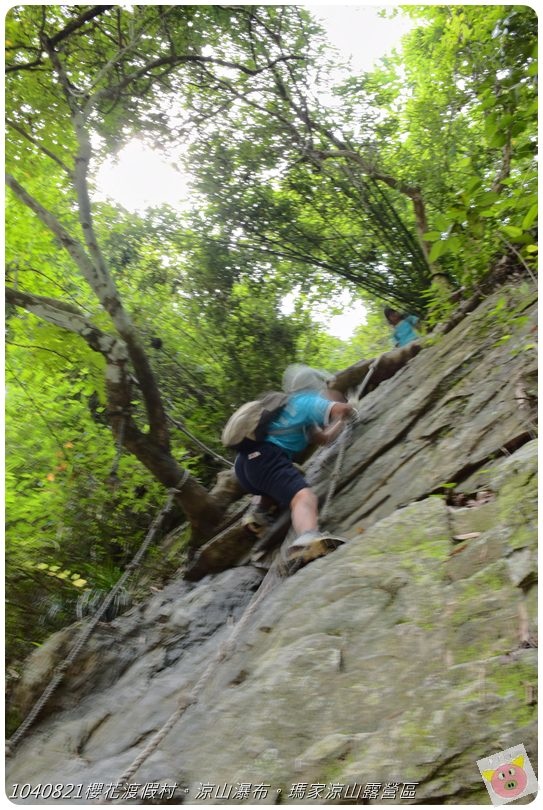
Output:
[{"xmin": 234, "ymin": 364, "xmax": 354, "ymax": 563}]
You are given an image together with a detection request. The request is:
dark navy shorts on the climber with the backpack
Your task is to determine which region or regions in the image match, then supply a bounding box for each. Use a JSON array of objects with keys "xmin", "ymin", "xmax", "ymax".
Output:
[{"xmin": 234, "ymin": 441, "xmax": 308, "ymax": 506}]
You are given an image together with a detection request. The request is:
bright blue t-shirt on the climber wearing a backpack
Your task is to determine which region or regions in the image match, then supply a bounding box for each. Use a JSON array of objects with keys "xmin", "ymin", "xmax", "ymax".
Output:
[{"xmin": 266, "ymin": 391, "xmax": 335, "ymax": 456}]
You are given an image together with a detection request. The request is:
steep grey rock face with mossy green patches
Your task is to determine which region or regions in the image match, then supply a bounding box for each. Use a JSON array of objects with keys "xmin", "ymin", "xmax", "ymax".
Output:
[{"xmin": 6, "ymin": 287, "xmax": 537, "ymax": 804}]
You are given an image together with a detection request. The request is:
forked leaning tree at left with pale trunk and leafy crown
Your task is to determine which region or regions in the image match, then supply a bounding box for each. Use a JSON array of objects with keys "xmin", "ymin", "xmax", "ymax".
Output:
[{"xmin": 6, "ymin": 6, "xmax": 312, "ymax": 542}]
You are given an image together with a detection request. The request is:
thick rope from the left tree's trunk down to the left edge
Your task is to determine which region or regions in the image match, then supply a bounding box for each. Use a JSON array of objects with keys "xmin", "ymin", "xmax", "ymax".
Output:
[{"xmin": 6, "ymin": 482, "xmax": 183, "ymax": 756}]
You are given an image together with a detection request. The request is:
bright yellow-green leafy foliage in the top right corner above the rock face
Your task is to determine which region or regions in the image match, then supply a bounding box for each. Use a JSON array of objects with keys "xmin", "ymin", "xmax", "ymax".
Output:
[{"xmin": 369, "ymin": 5, "xmax": 537, "ymax": 288}]
